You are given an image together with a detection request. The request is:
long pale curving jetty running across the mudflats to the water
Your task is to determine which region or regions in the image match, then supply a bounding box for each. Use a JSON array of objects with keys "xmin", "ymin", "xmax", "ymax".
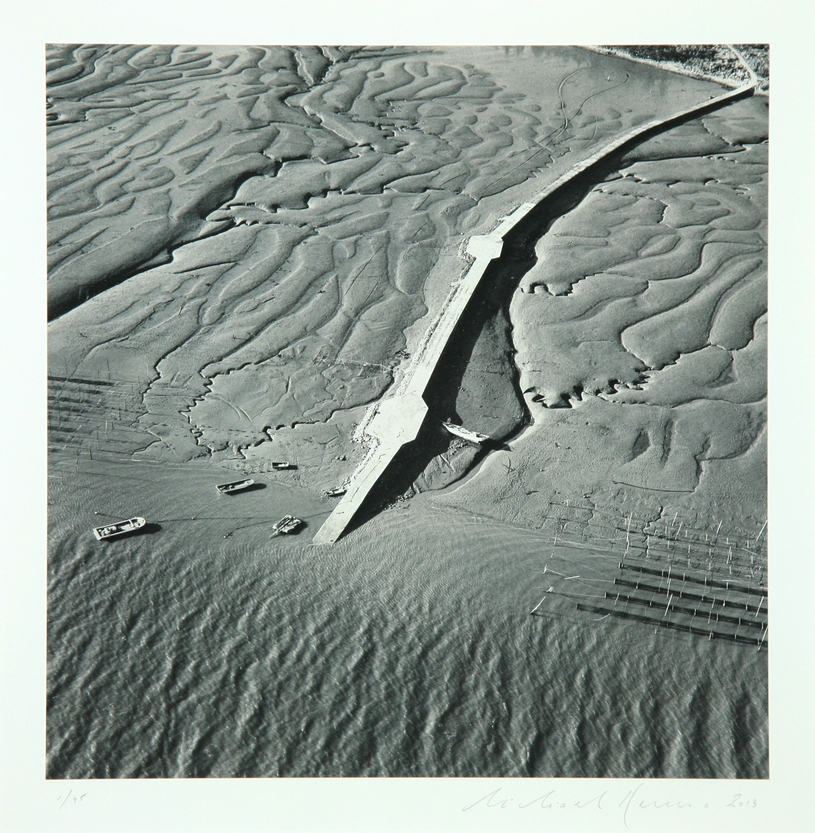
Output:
[{"xmin": 314, "ymin": 76, "xmax": 756, "ymax": 544}]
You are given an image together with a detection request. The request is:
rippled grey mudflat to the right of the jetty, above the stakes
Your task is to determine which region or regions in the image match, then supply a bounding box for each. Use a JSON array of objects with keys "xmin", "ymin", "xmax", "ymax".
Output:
[{"xmin": 450, "ymin": 99, "xmax": 767, "ymax": 520}]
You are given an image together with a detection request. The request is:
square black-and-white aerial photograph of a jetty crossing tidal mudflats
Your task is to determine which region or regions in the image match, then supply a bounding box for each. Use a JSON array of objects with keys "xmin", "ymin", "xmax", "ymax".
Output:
[{"xmin": 1, "ymin": 3, "xmax": 815, "ymax": 830}]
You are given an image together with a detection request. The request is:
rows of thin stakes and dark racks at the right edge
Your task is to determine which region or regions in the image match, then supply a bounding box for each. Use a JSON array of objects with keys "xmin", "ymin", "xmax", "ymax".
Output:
[{"xmin": 536, "ymin": 502, "xmax": 768, "ymax": 650}]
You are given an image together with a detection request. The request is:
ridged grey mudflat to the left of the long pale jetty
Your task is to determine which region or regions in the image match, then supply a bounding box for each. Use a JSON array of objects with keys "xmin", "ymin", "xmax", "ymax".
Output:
[{"xmin": 49, "ymin": 47, "xmax": 732, "ymax": 488}]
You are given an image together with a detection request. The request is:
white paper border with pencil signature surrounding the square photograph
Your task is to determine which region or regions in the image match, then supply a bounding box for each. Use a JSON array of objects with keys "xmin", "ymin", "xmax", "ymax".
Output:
[{"xmin": 0, "ymin": 0, "xmax": 815, "ymax": 833}]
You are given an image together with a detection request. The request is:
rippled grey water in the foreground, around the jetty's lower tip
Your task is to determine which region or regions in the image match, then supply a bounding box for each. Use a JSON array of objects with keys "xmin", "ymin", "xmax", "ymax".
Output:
[{"xmin": 48, "ymin": 452, "xmax": 767, "ymax": 778}]
